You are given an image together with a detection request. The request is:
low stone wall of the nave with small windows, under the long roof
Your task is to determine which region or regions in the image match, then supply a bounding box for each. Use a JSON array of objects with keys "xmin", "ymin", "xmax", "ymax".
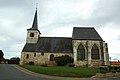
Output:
[{"xmin": 20, "ymin": 52, "xmax": 73, "ymax": 65}]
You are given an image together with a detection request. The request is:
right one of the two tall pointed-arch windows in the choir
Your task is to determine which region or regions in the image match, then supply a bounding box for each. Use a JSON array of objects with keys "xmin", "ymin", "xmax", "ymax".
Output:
[{"xmin": 91, "ymin": 44, "xmax": 100, "ymax": 59}]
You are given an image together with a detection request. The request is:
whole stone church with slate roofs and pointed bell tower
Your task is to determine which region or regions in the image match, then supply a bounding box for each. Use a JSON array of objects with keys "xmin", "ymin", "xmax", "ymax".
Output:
[{"xmin": 20, "ymin": 9, "xmax": 109, "ymax": 67}]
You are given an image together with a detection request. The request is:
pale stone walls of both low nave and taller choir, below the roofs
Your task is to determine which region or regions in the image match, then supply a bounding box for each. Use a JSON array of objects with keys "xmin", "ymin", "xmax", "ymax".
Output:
[{"xmin": 20, "ymin": 40, "xmax": 109, "ymax": 66}]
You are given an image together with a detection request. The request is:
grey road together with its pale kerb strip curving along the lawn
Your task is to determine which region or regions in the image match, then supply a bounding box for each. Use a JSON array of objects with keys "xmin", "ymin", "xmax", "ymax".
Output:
[{"xmin": 0, "ymin": 64, "xmax": 120, "ymax": 80}]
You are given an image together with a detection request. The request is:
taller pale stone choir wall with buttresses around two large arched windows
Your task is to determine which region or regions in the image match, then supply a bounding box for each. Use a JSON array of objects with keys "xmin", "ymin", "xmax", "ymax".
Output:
[{"xmin": 72, "ymin": 40, "xmax": 107, "ymax": 66}]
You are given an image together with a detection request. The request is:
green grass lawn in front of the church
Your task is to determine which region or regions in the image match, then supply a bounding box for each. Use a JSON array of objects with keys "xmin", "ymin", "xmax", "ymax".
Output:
[{"xmin": 22, "ymin": 65, "xmax": 99, "ymax": 77}]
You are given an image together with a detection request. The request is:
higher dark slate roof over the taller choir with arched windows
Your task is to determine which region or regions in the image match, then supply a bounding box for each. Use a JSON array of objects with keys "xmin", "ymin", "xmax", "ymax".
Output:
[{"xmin": 72, "ymin": 27, "xmax": 103, "ymax": 40}]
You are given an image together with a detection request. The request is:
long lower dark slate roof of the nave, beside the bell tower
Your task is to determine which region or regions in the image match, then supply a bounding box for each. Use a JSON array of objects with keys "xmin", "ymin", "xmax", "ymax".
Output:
[{"xmin": 22, "ymin": 37, "xmax": 72, "ymax": 53}]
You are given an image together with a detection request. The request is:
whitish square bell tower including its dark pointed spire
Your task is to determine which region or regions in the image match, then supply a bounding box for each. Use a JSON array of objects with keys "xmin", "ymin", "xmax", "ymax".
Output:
[{"xmin": 26, "ymin": 9, "xmax": 41, "ymax": 43}]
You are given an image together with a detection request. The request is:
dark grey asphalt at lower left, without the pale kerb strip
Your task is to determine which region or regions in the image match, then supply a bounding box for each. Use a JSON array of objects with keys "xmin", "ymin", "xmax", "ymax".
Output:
[{"xmin": 0, "ymin": 64, "xmax": 55, "ymax": 80}]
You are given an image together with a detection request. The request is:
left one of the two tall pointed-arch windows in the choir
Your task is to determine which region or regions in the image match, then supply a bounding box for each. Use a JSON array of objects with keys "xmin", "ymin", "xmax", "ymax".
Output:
[{"xmin": 77, "ymin": 44, "xmax": 85, "ymax": 60}]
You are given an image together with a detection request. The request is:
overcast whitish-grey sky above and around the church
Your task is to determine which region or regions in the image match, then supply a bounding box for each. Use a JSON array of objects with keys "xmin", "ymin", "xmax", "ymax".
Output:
[{"xmin": 0, "ymin": 0, "xmax": 120, "ymax": 59}]
